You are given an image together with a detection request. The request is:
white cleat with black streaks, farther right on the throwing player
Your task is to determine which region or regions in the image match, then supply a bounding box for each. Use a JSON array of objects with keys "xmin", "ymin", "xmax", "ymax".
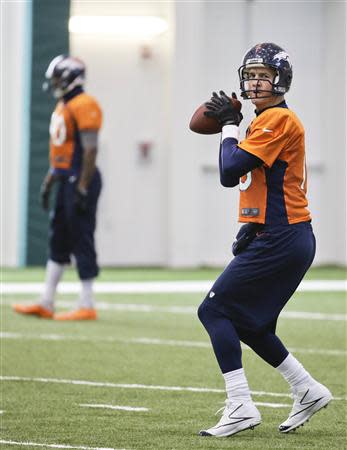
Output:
[{"xmin": 278, "ymin": 383, "xmax": 333, "ymax": 433}]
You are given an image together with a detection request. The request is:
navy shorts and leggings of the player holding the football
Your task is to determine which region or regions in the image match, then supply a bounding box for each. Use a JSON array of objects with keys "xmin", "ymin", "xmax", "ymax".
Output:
[{"xmin": 198, "ymin": 222, "xmax": 316, "ymax": 373}]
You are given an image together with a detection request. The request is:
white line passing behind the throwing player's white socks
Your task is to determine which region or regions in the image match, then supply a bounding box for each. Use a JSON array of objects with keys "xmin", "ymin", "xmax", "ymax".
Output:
[{"xmin": 0, "ymin": 375, "xmax": 346, "ymax": 400}]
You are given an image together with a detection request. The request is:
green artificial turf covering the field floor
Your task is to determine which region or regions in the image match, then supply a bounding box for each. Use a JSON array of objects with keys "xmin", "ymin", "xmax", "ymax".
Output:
[{"xmin": 0, "ymin": 269, "xmax": 347, "ymax": 450}]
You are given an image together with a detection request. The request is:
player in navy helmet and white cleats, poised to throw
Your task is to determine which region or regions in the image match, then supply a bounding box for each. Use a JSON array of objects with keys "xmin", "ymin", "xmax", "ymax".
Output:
[{"xmin": 198, "ymin": 43, "xmax": 332, "ymax": 437}]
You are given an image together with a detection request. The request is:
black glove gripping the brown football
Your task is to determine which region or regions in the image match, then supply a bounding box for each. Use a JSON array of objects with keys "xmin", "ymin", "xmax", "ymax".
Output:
[{"xmin": 204, "ymin": 91, "xmax": 243, "ymax": 126}]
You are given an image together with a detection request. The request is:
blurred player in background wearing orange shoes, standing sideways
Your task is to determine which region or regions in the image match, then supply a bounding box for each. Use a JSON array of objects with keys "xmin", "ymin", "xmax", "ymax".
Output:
[{"xmin": 14, "ymin": 55, "xmax": 102, "ymax": 320}]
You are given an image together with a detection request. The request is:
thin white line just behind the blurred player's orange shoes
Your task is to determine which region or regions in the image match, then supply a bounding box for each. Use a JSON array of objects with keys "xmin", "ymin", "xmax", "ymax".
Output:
[{"xmin": 3, "ymin": 300, "xmax": 347, "ymax": 322}]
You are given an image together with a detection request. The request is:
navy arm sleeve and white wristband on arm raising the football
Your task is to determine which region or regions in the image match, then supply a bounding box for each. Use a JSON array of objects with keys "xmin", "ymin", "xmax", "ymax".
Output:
[{"xmin": 219, "ymin": 125, "xmax": 263, "ymax": 187}]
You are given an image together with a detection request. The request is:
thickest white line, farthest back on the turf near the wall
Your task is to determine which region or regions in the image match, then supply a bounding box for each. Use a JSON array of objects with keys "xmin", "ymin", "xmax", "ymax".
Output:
[{"xmin": 0, "ymin": 280, "xmax": 347, "ymax": 294}]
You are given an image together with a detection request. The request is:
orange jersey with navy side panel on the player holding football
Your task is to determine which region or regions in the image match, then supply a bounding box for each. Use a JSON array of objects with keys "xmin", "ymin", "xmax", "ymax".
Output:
[{"xmin": 238, "ymin": 107, "xmax": 311, "ymax": 224}]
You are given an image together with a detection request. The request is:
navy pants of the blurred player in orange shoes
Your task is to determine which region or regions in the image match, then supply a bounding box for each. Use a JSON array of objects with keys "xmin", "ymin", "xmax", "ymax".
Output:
[{"xmin": 49, "ymin": 170, "xmax": 102, "ymax": 280}]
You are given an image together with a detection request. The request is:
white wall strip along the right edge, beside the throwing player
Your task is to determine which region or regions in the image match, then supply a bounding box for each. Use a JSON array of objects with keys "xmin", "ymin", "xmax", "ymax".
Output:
[{"xmin": 318, "ymin": 2, "xmax": 347, "ymax": 264}]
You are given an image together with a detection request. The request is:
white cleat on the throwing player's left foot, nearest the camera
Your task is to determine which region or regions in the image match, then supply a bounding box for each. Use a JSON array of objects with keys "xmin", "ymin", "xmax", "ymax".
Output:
[{"xmin": 199, "ymin": 400, "xmax": 261, "ymax": 437}]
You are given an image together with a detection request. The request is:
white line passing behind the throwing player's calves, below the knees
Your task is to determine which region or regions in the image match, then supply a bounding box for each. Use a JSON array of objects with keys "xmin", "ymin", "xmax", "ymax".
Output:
[{"xmin": 0, "ymin": 331, "xmax": 347, "ymax": 356}]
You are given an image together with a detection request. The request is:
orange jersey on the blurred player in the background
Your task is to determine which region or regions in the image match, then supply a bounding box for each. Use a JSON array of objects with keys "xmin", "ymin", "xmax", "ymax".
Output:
[{"xmin": 49, "ymin": 92, "xmax": 102, "ymax": 170}]
